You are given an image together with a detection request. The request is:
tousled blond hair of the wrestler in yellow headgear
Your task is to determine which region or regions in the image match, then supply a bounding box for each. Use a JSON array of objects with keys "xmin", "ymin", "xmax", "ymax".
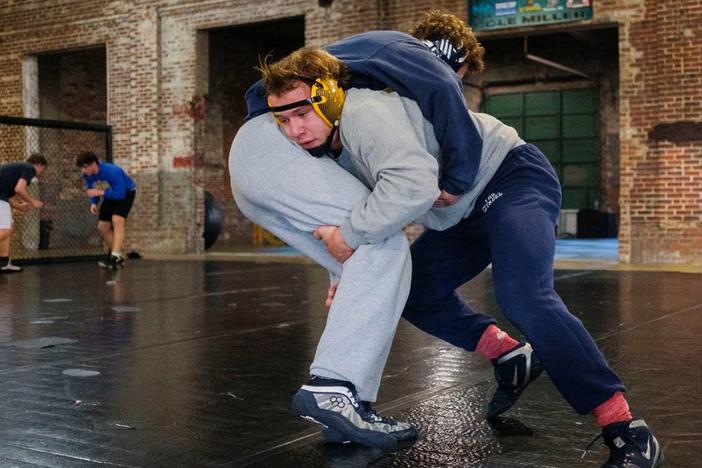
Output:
[{"xmin": 256, "ymin": 46, "xmax": 349, "ymax": 96}]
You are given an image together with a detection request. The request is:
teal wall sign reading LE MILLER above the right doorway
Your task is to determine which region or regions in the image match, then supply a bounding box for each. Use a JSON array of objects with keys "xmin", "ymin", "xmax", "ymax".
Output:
[{"xmin": 469, "ymin": 0, "xmax": 592, "ymax": 31}]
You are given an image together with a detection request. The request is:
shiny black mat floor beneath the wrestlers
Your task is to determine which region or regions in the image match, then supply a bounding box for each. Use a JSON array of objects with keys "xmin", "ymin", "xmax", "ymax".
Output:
[{"xmin": 0, "ymin": 260, "xmax": 702, "ymax": 467}]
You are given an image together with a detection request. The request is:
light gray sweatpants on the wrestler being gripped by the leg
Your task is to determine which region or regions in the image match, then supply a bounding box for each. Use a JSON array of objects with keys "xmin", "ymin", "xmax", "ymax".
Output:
[{"xmin": 229, "ymin": 114, "xmax": 412, "ymax": 401}]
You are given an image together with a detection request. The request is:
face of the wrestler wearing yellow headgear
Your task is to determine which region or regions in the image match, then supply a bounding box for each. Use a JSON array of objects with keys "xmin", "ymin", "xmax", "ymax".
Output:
[{"xmin": 268, "ymin": 81, "xmax": 331, "ymax": 149}]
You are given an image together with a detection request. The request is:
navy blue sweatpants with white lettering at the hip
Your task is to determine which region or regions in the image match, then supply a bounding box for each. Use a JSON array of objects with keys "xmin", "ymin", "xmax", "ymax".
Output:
[{"xmin": 403, "ymin": 145, "xmax": 624, "ymax": 414}]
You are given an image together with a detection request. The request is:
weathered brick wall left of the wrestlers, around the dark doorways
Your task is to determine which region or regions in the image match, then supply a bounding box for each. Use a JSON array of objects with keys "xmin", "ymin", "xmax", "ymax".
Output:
[{"xmin": 0, "ymin": 0, "xmax": 468, "ymax": 252}]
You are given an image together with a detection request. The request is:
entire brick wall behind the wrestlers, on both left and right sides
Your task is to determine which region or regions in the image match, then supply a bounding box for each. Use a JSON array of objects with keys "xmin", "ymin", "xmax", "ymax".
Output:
[{"xmin": 0, "ymin": 0, "xmax": 702, "ymax": 262}]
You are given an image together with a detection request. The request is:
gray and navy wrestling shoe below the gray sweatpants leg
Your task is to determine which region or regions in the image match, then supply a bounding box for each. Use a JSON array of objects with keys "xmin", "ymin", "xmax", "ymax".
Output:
[{"xmin": 292, "ymin": 376, "xmax": 417, "ymax": 451}]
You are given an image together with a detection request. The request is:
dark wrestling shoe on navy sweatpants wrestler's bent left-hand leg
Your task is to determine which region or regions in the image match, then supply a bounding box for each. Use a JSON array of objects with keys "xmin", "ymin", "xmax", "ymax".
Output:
[{"xmin": 487, "ymin": 343, "xmax": 544, "ymax": 419}]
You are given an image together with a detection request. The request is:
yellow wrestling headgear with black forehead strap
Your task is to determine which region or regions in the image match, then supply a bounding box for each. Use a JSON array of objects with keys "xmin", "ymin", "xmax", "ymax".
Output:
[{"xmin": 268, "ymin": 76, "xmax": 346, "ymax": 128}]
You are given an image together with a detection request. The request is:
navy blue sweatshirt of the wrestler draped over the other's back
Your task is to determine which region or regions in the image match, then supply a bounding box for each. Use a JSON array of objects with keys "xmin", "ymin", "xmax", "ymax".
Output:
[{"xmin": 246, "ymin": 31, "xmax": 483, "ymax": 195}]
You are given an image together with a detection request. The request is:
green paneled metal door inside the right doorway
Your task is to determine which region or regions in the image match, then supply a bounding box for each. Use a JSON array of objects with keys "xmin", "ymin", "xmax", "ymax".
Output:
[{"xmin": 485, "ymin": 88, "xmax": 600, "ymax": 209}]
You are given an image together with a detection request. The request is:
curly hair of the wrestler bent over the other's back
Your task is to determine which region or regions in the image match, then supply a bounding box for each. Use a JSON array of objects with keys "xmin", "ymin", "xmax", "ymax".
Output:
[{"xmin": 409, "ymin": 10, "xmax": 485, "ymax": 73}]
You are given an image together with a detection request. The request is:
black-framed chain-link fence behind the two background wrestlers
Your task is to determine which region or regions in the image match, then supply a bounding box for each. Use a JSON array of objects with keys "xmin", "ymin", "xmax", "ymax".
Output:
[{"xmin": 0, "ymin": 116, "xmax": 112, "ymax": 262}]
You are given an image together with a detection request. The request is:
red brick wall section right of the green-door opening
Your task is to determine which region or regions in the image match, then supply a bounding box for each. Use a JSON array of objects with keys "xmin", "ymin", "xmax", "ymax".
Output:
[{"xmin": 595, "ymin": 0, "xmax": 702, "ymax": 263}]
